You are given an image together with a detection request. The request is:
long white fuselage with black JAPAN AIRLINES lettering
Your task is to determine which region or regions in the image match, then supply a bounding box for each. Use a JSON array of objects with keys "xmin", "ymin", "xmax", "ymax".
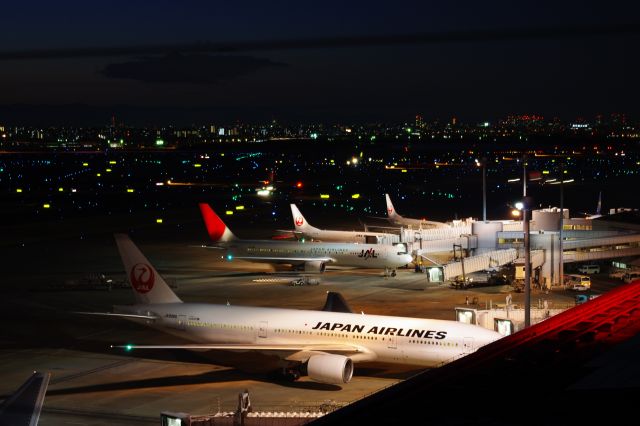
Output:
[{"xmin": 117, "ymin": 303, "xmax": 502, "ymax": 367}]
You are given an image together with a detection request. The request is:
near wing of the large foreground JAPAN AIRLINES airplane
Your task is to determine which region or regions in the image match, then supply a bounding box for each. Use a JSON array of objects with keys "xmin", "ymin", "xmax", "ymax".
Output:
[{"xmin": 111, "ymin": 343, "xmax": 376, "ymax": 362}]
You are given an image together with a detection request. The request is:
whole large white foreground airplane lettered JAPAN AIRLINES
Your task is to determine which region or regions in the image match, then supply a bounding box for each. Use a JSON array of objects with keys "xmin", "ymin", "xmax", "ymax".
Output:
[{"xmin": 83, "ymin": 234, "xmax": 502, "ymax": 384}]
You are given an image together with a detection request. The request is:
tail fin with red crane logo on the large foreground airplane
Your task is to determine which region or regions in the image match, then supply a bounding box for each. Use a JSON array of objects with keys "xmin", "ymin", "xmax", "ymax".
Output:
[{"xmin": 114, "ymin": 234, "xmax": 182, "ymax": 304}]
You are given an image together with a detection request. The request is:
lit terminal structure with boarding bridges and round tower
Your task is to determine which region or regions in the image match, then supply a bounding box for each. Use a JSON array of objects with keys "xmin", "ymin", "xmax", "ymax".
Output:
[{"xmin": 401, "ymin": 207, "xmax": 640, "ymax": 288}]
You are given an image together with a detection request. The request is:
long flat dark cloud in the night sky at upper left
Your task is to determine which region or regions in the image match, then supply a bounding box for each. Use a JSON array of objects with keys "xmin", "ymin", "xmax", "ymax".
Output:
[{"xmin": 102, "ymin": 54, "xmax": 287, "ymax": 84}]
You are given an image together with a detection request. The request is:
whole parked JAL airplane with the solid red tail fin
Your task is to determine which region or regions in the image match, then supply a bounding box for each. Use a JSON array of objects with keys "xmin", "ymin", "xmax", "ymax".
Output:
[{"xmin": 199, "ymin": 203, "xmax": 413, "ymax": 275}]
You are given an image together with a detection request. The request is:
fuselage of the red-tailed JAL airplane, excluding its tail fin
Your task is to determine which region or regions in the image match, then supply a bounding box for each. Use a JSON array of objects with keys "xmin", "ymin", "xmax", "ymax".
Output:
[{"xmin": 221, "ymin": 240, "xmax": 413, "ymax": 269}]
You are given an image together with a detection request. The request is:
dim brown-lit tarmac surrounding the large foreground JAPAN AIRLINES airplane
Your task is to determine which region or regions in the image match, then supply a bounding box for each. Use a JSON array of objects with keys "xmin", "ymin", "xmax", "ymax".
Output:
[{"xmin": 0, "ymin": 218, "xmax": 584, "ymax": 425}]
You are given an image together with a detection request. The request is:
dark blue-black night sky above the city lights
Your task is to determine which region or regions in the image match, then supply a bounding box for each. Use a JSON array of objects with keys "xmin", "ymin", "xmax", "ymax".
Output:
[{"xmin": 0, "ymin": 0, "xmax": 640, "ymax": 124}]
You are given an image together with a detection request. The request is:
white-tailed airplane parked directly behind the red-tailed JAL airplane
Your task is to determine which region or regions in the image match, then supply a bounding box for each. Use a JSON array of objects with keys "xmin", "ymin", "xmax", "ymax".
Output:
[{"xmin": 291, "ymin": 204, "xmax": 400, "ymax": 244}]
